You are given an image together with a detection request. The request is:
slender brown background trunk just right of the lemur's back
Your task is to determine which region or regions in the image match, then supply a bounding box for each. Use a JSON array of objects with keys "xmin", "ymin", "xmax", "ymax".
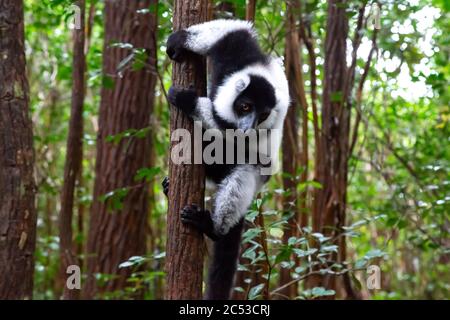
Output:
[{"xmin": 279, "ymin": 0, "xmax": 308, "ymax": 298}]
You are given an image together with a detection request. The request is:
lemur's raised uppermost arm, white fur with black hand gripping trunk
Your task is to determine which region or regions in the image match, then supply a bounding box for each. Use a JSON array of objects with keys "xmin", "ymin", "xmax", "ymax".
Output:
[{"xmin": 167, "ymin": 20, "xmax": 254, "ymax": 61}]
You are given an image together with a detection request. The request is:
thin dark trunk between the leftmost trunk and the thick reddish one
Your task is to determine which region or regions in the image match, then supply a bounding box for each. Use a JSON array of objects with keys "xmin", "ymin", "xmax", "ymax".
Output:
[{"xmin": 59, "ymin": 0, "xmax": 86, "ymax": 300}]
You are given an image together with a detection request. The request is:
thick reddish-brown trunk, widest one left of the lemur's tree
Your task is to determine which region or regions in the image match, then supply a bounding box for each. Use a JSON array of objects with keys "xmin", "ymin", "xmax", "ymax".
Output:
[{"xmin": 84, "ymin": 0, "xmax": 157, "ymax": 298}]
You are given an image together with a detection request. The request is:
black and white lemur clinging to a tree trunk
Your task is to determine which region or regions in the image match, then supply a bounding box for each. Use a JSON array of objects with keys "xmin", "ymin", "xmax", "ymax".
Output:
[{"xmin": 163, "ymin": 20, "xmax": 289, "ymax": 299}]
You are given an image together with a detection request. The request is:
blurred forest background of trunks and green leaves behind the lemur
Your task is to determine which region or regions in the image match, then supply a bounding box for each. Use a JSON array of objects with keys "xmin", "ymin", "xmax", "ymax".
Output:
[{"xmin": 0, "ymin": 0, "xmax": 450, "ymax": 299}]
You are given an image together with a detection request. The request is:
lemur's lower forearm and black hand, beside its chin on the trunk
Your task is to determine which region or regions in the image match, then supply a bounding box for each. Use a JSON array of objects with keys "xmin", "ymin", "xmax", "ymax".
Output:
[{"xmin": 168, "ymin": 87, "xmax": 219, "ymax": 129}]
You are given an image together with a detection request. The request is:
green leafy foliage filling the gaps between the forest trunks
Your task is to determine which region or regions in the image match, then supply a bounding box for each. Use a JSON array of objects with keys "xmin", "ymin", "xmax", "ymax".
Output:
[{"xmin": 25, "ymin": 0, "xmax": 450, "ymax": 299}]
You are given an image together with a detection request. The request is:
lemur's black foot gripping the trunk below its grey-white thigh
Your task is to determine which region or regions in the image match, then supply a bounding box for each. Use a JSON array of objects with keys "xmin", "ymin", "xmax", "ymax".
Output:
[{"xmin": 181, "ymin": 204, "xmax": 219, "ymax": 241}]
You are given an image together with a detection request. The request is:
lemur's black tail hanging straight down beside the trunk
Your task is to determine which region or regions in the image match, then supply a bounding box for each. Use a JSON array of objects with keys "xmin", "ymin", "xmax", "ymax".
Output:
[{"xmin": 205, "ymin": 220, "xmax": 244, "ymax": 300}]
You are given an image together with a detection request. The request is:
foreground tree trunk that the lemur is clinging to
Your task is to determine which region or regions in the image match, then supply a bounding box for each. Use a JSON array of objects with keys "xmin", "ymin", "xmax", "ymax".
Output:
[{"xmin": 166, "ymin": 0, "xmax": 208, "ymax": 299}]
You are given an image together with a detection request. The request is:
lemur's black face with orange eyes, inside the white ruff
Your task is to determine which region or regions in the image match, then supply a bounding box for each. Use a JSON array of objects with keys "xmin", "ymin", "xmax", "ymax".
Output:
[{"xmin": 233, "ymin": 76, "xmax": 276, "ymax": 131}]
